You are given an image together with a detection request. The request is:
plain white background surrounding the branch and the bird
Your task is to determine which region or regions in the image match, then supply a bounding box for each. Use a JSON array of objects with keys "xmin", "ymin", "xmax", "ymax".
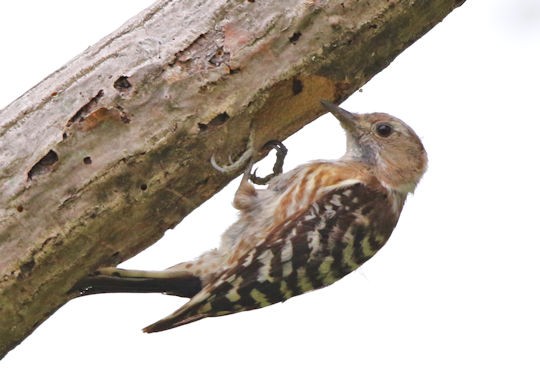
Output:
[{"xmin": 0, "ymin": 0, "xmax": 540, "ymax": 378}]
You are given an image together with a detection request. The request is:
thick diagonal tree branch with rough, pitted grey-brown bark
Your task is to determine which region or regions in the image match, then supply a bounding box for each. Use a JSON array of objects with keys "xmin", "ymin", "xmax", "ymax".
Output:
[{"xmin": 0, "ymin": 0, "xmax": 463, "ymax": 357}]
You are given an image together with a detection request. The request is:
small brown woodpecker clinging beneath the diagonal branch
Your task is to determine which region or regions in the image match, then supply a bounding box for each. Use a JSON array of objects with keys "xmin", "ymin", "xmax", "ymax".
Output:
[{"xmin": 78, "ymin": 101, "xmax": 427, "ymax": 332}]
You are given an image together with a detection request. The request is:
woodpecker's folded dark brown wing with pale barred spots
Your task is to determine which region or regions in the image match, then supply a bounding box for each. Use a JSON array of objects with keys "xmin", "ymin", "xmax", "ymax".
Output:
[{"xmin": 144, "ymin": 183, "xmax": 399, "ymax": 332}]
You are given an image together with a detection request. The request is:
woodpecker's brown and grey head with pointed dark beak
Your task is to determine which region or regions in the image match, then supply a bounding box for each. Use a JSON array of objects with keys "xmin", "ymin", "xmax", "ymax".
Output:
[{"xmin": 321, "ymin": 101, "xmax": 427, "ymax": 193}]
